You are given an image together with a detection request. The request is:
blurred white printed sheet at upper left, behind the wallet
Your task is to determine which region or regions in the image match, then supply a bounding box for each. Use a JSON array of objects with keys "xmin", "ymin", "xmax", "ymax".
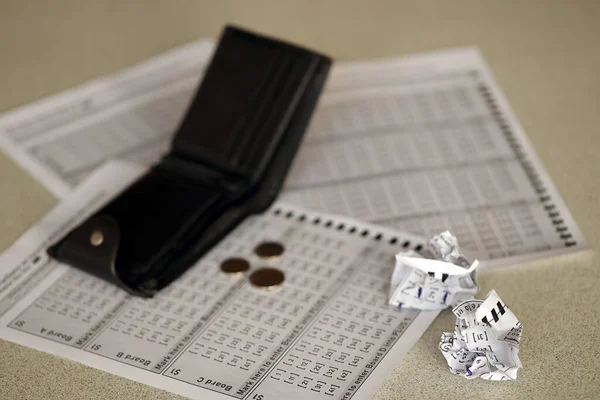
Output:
[{"xmin": 0, "ymin": 40, "xmax": 213, "ymax": 198}]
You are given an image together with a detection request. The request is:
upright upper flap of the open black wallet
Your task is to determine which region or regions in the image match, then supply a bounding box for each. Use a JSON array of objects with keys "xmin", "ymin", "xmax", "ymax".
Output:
[{"xmin": 172, "ymin": 27, "xmax": 323, "ymax": 184}]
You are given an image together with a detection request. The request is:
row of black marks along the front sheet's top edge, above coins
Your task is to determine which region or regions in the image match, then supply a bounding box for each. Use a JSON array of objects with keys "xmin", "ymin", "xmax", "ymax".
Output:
[{"xmin": 272, "ymin": 208, "xmax": 423, "ymax": 251}]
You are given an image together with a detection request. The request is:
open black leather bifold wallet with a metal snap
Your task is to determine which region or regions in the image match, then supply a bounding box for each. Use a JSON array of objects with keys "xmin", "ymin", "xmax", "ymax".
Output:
[{"xmin": 48, "ymin": 27, "xmax": 331, "ymax": 297}]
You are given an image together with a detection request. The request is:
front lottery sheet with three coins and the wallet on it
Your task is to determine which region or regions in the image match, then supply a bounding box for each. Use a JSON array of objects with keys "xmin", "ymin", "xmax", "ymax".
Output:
[{"xmin": 0, "ymin": 161, "xmax": 437, "ymax": 400}]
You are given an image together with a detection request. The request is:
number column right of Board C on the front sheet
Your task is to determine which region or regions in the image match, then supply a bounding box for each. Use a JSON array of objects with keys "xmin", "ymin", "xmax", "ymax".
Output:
[{"xmin": 260, "ymin": 251, "xmax": 416, "ymax": 399}]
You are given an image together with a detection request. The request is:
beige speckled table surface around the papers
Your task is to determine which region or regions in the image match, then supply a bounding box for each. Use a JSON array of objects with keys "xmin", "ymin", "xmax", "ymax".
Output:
[{"xmin": 0, "ymin": 0, "xmax": 600, "ymax": 400}]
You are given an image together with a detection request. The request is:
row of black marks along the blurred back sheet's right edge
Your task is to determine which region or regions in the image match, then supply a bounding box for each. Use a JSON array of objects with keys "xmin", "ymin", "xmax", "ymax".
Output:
[{"xmin": 478, "ymin": 82, "xmax": 577, "ymax": 247}]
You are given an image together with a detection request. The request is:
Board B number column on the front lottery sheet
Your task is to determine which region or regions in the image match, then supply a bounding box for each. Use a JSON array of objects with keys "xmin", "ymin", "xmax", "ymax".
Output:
[{"xmin": 79, "ymin": 216, "xmax": 290, "ymax": 372}]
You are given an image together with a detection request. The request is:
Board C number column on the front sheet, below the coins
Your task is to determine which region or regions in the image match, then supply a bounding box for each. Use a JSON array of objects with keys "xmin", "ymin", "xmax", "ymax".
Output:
[{"xmin": 166, "ymin": 217, "xmax": 364, "ymax": 397}]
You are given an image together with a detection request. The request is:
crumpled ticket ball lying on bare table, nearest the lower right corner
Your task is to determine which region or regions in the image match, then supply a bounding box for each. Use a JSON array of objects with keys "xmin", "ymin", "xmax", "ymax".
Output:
[{"xmin": 440, "ymin": 290, "xmax": 523, "ymax": 381}]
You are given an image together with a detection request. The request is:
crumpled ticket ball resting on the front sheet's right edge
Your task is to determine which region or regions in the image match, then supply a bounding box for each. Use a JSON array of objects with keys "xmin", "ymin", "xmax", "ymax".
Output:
[{"xmin": 389, "ymin": 231, "xmax": 479, "ymax": 311}]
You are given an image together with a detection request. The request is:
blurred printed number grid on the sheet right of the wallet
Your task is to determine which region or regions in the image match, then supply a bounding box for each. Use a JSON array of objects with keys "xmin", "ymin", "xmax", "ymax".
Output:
[{"xmin": 282, "ymin": 75, "xmax": 562, "ymax": 258}]
